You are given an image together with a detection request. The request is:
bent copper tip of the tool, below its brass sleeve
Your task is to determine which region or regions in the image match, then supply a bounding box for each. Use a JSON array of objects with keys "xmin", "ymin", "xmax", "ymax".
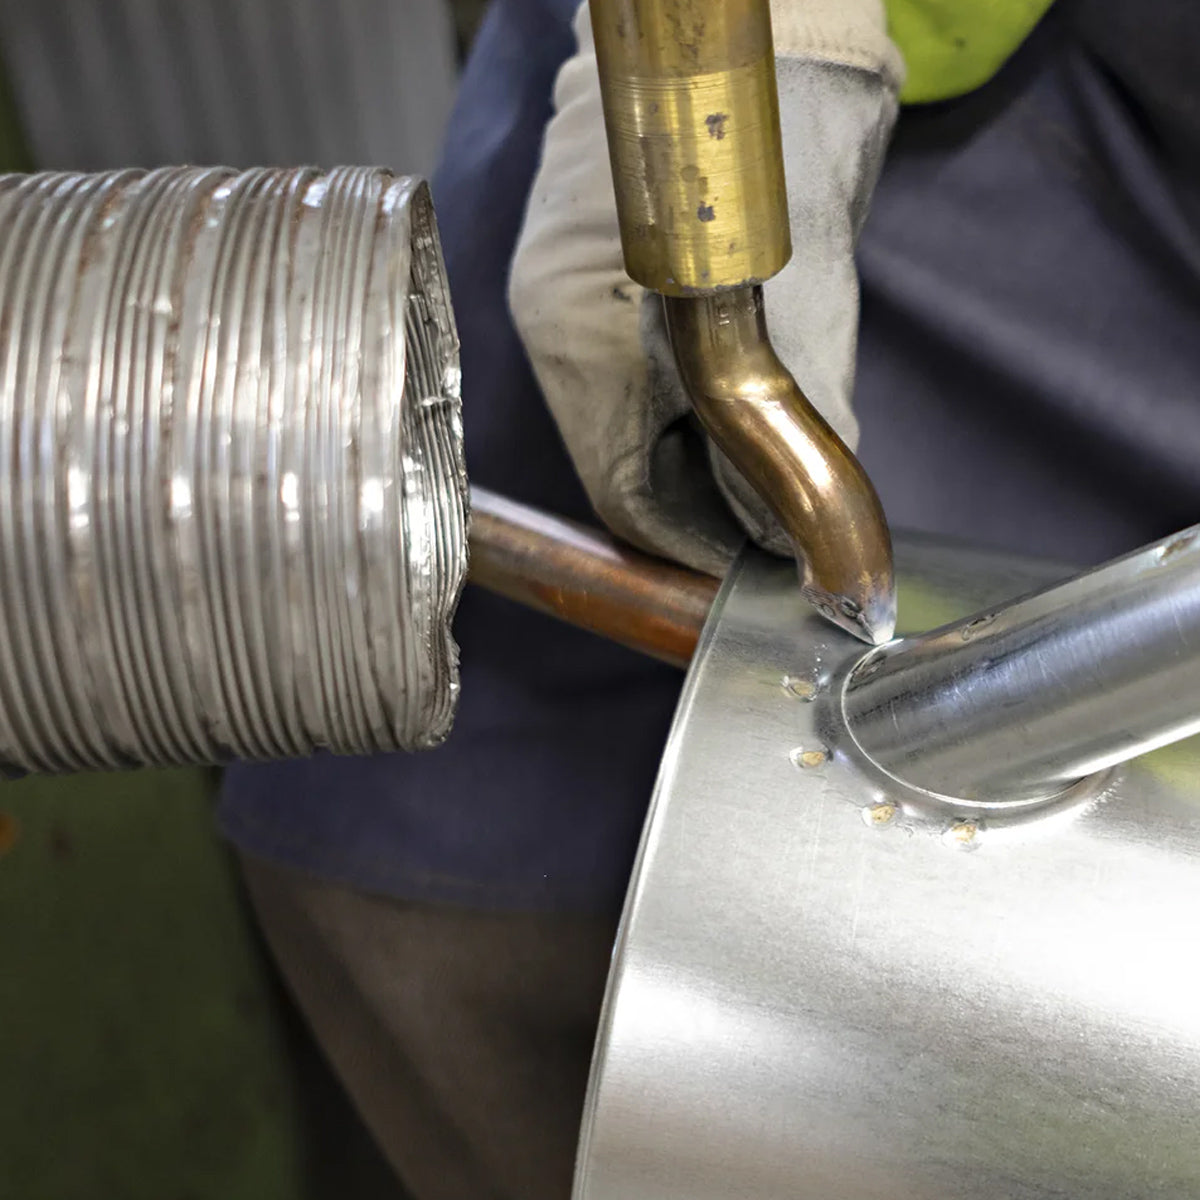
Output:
[{"xmin": 662, "ymin": 287, "xmax": 896, "ymax": 643}]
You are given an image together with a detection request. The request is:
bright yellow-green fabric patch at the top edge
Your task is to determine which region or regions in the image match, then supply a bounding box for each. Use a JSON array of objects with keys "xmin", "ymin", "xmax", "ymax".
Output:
[{"xmin": 886, "ymin": 0, "xmax": 1051, "ymax": 104}]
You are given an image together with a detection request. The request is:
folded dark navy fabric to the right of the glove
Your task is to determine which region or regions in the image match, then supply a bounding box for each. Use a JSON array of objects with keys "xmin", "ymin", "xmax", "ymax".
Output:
[{"xmin": 856, "ymin": 0, "xmax": 1200, "ymax": 562}]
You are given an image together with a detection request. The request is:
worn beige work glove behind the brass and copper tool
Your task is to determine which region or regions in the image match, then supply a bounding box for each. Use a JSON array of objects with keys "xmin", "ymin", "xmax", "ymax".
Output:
[{"xmin": 509, "ymin": 0, "xmax": 902, "ymax": 575}]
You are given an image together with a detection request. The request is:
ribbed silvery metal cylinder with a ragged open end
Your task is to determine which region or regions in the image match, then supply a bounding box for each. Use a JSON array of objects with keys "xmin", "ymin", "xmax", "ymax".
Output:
[{"xmin": 0, "ymin": 168, "xmax": 467, "ymax": 773}]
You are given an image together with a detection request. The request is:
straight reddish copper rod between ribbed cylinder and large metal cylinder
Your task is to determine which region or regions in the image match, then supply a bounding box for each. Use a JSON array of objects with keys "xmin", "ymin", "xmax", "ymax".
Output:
[{"xmin": 469, "ymin": 487, "xmax": 720, "ymax": 667}]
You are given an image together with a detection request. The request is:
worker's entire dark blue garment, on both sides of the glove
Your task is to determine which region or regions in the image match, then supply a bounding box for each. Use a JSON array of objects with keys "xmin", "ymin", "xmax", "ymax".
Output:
[{"xmin": 222, "ymin": 0, "xmax": 1200, "ymax": 911}]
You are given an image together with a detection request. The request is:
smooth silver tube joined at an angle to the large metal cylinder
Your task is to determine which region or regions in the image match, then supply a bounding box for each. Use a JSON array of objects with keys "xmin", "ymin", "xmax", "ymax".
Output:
[{"xmin": 842, "ymin": 526, "xmax": 1200, "ymax": 804}]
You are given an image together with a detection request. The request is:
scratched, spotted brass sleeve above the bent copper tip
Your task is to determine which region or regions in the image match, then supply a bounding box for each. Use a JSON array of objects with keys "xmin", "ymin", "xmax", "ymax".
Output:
[{"xmin": 592, "ymin": 0, "xmax": 792, "ymax": 295}]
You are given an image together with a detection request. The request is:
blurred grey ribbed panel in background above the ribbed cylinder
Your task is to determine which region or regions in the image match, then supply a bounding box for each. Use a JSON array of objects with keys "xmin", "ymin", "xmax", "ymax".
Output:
[{"xmin": 0, "ymin": 0, "xmax": 454, "ymax": 174}]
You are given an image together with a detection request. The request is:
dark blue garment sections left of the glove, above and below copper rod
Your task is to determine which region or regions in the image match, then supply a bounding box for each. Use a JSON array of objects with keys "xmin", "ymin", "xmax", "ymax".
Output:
[{"xmin": 221, "ymin": 0, "xmax": 682, "ymax": 912}]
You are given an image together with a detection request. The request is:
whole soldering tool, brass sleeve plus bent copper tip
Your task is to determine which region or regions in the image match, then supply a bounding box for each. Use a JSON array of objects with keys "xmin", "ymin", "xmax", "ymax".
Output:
[{"xmin": 590, "ymin": 0, "xmax": 895, "ymax": 642}]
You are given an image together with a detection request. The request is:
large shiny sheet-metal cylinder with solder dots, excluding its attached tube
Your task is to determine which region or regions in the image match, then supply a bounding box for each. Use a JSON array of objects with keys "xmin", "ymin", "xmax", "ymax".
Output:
[{"xmin": 575, "ymin": 539, "xmax": 1200, "ymax": 1200}]
